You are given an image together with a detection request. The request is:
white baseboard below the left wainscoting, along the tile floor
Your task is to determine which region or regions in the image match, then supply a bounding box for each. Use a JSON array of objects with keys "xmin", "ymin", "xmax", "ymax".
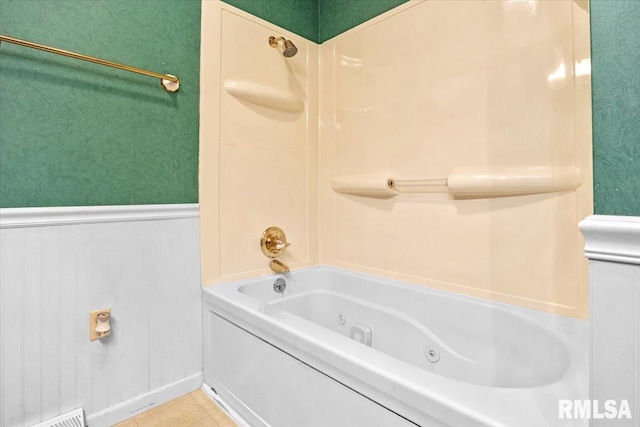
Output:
[{"xmin": 86, "ymin": 372, "xmax": 203, "ymax": 427}]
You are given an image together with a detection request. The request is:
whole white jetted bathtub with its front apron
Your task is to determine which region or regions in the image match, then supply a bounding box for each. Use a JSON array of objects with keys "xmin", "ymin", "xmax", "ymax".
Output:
[{"xmin": 204, "ymin": 267, "xmax": 588, "ymax": 427}]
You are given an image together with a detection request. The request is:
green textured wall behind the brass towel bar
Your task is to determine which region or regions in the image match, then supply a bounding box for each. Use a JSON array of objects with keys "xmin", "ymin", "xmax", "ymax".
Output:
[{"xmin": 0, "ymin": 0, "xmax": 200, "ymax": 207}]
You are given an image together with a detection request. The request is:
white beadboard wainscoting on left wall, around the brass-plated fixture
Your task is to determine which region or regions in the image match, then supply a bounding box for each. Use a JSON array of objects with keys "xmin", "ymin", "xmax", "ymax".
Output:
[{"xmin": 0, "ymin": 205, "xmax": 202, "ymax": 427}]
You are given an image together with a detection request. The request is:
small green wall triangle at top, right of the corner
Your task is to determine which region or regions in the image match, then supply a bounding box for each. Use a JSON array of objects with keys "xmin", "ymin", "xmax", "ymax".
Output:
[{"xmin": 317, "ymin": 0, "xmax": 408, "ymax": 43}]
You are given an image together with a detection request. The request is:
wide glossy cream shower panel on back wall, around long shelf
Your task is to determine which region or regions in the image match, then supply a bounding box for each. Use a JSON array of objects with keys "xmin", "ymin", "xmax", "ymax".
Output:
[{"xmin": 320, "ymin": 0, "xmax": 592, "ymax": 317}]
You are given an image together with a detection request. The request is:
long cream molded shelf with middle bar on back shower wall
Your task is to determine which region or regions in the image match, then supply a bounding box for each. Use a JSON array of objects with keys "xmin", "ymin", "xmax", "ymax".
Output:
[{"xmin": 331, "ymin": 167, "xmax": 583, "ymax": 199}]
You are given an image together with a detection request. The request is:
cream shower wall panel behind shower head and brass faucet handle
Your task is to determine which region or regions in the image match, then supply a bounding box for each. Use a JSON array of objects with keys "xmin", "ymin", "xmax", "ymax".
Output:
[{"xmin": 200, "ymin": 2, "xmax": 318, "ymax": 285}]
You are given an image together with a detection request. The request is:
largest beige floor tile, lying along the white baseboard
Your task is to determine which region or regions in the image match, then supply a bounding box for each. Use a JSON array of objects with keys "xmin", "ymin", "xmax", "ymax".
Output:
[{"xmin": 134, "ymin": 394, "xmax": 207, "ymax": 427}]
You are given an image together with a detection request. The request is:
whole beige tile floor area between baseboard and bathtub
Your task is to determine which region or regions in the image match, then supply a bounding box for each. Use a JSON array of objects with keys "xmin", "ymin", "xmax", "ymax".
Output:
[{"xmin": 114, "ymin": 390, "xmax": 238, "ymax": 427}]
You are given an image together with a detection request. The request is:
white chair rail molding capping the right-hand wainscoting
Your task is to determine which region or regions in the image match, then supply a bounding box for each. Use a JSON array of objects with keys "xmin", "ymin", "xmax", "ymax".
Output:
[{"xmin": 579, "ymin": 215, "xmax": 640, "ymax": 265}]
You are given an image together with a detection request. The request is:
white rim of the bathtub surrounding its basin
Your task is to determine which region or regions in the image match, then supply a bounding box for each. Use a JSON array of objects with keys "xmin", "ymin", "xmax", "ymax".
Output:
[{"xmin": 203, "ymin": 265, "xmax": 588, "ymax": 426}]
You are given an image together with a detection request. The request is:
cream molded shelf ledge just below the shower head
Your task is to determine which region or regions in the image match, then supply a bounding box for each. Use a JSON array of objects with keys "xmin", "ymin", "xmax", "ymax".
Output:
[{"xmin": 224, "ymin": 80, "xmax": 304, "ymax": 113}]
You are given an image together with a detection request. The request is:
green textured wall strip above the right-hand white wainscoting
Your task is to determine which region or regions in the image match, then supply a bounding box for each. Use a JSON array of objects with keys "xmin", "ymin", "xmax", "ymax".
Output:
[{"xmin": 591, "ymin": 0, "xmax": 640, "ymax": 216}]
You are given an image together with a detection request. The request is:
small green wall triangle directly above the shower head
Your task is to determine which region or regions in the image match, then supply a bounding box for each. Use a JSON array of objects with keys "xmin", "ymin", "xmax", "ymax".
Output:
[{"xmin": 224, "ymin": 0, "xmax": 318, "ymax": 42}]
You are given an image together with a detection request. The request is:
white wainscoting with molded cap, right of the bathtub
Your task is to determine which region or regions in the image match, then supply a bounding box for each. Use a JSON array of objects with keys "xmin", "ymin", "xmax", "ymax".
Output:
[{"xmin": 580, "ymin": 215, "xmax": 640, "ymax": 427}]
